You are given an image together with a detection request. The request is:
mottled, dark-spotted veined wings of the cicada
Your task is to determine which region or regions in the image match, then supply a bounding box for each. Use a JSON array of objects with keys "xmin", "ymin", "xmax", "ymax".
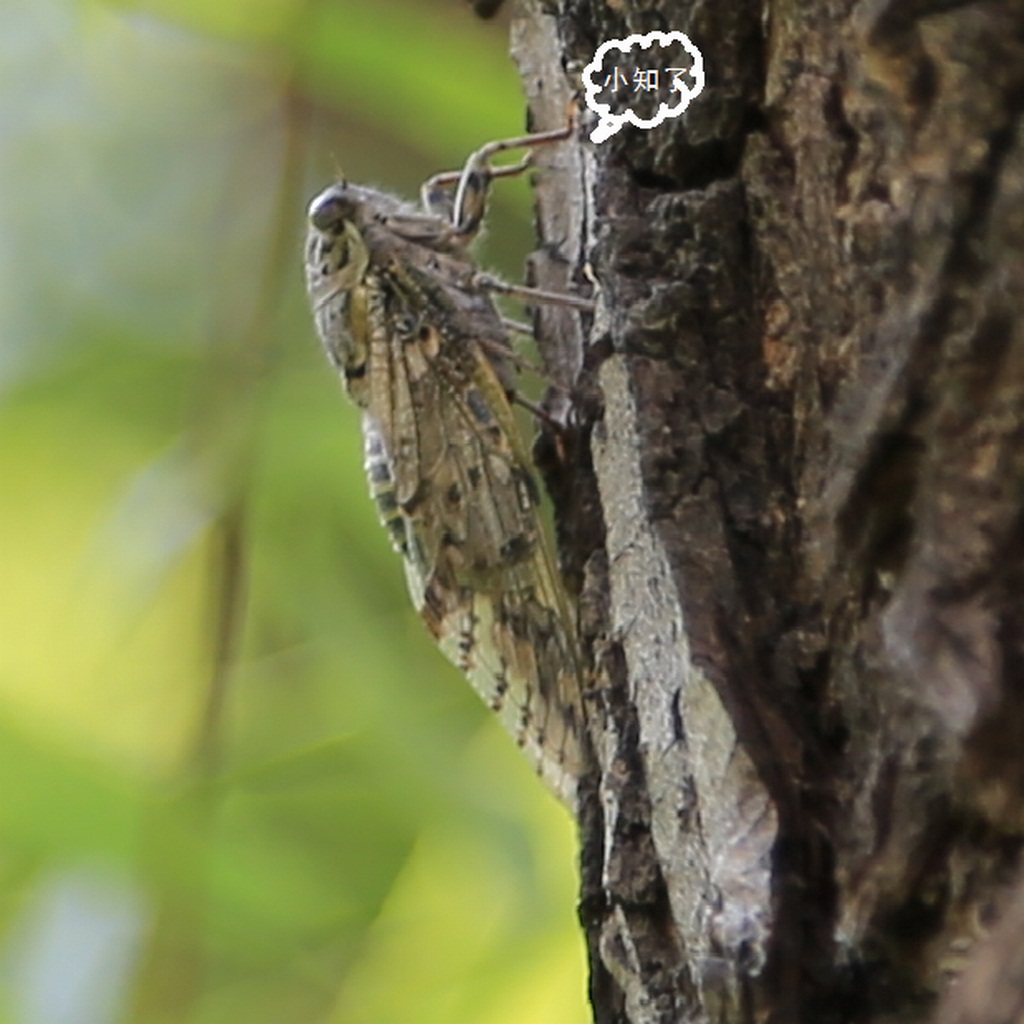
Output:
[{"xmin": 364, "ymin": 264, "xmax": 582, "ymax": 804}]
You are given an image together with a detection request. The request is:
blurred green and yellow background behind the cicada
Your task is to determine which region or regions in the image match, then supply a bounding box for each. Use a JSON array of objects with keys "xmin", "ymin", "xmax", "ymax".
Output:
[{"xmin": 0, "ymin": 0, "xmax": 588, "ymax": 1024}]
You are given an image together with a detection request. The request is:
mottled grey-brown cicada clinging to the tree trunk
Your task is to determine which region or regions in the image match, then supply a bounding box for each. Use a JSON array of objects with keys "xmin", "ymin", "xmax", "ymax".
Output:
[{"xmin": 306, "ymin": 130, "xmax": 584, "ymax": 806}]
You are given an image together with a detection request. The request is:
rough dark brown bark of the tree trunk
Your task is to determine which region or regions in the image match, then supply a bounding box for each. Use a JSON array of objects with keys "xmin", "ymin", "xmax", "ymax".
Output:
[{"xmin": 513, "ymin": 0, "xmax": 1024, "ymax": 1024}]
